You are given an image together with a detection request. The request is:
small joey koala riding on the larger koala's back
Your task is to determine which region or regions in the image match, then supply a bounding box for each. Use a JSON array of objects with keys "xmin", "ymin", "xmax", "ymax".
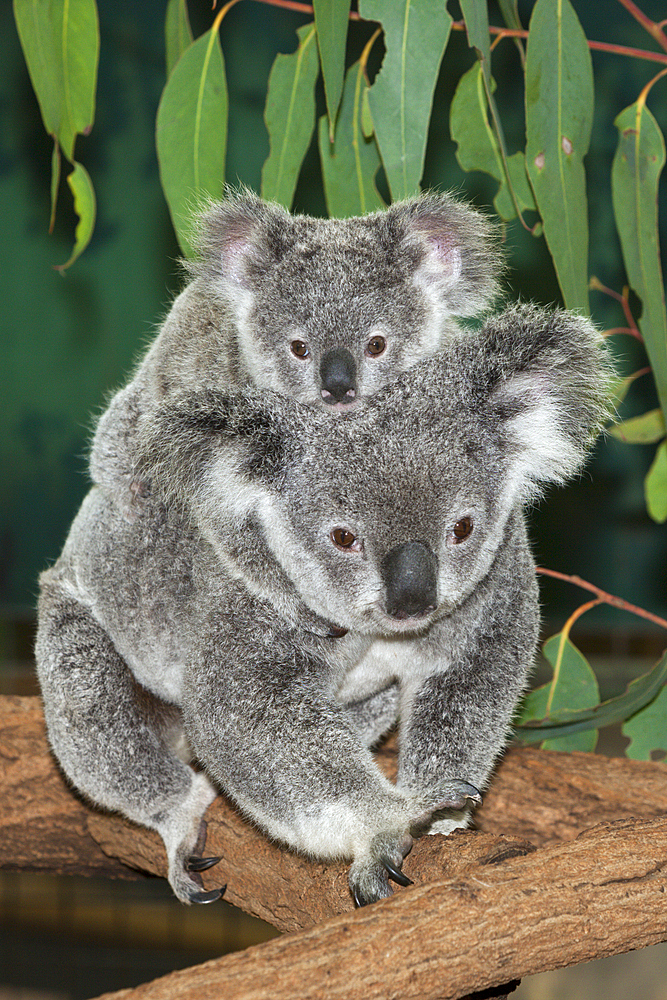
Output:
[{"xmin": 90, "ymin": 191, "xmax": 502, "ymax": 508}]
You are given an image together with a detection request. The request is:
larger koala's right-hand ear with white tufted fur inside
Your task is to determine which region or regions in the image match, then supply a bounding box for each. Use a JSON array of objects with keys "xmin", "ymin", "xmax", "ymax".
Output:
[{"xmin": 476, "ymin": 305, "xmax": 614, "ymax": 499}]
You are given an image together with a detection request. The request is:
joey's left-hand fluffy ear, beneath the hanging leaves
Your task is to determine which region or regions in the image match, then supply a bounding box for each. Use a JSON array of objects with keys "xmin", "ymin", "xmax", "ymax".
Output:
[{"xmin": 188, "ymin": 189, "xmax": 291, "ymax": 288}]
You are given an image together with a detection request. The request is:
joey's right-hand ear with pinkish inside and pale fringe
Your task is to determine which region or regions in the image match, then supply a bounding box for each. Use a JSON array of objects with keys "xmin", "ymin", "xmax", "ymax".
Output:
[{"xmin": 385, "ymin": 193, "xmax": 503, "ymax": 316}]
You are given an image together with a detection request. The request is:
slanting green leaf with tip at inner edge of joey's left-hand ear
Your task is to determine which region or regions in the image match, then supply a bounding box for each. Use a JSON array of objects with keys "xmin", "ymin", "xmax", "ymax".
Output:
[{"xmin": 262, "ymin": 24, "xmax": 319, "ymax": 208}]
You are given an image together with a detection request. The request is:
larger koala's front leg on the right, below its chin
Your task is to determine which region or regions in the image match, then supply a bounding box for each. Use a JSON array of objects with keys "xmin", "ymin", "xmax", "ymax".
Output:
[{"xmin": 398, "ymin": 579, "xmax": 538, "ymax": 833}]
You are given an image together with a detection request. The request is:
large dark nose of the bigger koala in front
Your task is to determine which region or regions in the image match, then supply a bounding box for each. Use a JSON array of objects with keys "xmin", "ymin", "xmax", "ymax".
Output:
[{"xmin": 382, "ymin": 542, "xmax": 438, "ymax": 618}]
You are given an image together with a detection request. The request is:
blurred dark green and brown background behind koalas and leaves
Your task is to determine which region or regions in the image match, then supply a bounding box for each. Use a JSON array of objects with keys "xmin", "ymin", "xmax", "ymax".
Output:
[{"xmin": 0, "ymin": 0, "xmax": 667, "ymax": 1000}]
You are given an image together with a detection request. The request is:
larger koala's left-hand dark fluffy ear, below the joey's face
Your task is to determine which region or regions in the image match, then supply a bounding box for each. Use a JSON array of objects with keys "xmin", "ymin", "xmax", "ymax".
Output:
[{"xmin": 135, "ymin": 390, "xmax": 293, "ymax": 514}]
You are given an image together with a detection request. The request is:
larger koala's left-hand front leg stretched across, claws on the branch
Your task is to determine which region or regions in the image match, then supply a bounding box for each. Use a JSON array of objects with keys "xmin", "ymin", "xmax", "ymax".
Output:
[{"xmin": 183, "ymin": 608, "xmax": 430, "ymax": 903}]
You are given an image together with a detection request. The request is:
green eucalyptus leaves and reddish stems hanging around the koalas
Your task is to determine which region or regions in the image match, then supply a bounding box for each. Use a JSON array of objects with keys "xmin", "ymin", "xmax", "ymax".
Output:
[{"xmin": 14, "ymin": 0, "xmax": 667, "ymax": 757}]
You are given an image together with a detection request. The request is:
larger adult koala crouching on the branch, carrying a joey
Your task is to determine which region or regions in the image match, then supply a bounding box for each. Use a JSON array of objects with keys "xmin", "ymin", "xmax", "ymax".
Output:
[{"xmin": 36, "ymin": 305, "xmax": 611, "ymax": 905}]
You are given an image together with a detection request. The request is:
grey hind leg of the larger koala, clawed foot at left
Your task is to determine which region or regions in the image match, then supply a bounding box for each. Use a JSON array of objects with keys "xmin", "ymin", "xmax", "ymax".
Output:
[{"xmin": 36, "ymin": 573, "xmax": 222, "ymax": 903}]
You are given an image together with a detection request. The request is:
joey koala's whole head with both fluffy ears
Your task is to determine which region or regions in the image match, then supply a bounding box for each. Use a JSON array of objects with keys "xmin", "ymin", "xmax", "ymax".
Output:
[{"xmin": 190, "ymin": 194, "xmax": 501, "ymax": 412}]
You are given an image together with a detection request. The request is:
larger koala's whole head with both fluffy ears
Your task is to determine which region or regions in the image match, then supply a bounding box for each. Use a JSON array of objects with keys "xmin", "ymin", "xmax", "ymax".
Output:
[{"xmin": 144, "ymin": 306, "xmax": 610, "ymax": 635}]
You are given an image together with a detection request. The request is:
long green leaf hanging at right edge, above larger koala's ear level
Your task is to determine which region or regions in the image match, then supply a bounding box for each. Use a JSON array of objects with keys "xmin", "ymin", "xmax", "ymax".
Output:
[{"xmin": 612, "ymin": 101, "xmax": 667, "ymax": 424}]
